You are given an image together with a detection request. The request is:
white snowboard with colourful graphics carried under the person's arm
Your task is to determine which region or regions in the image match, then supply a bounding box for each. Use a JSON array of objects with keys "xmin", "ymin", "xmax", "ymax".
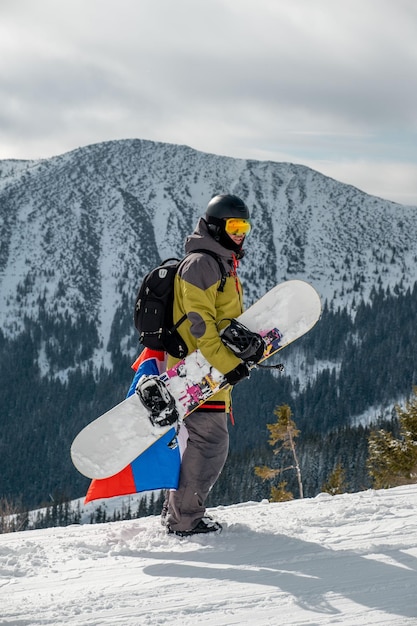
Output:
[{"xmin": 71, "ymin": 280, "xmax": 321, "ymax": 479}]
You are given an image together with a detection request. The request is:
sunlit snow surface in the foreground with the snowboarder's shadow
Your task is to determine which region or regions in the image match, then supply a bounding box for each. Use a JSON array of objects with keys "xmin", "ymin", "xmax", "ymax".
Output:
[{"xmin": 0, "ymin": 485, "xmax": 417, "ymax": 626}]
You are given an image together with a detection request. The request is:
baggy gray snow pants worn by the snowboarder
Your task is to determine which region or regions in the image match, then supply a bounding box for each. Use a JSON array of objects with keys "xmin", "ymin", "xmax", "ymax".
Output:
[{"xmin": 166, "ymin": 411, "xmax": 229, "ymax": 530}]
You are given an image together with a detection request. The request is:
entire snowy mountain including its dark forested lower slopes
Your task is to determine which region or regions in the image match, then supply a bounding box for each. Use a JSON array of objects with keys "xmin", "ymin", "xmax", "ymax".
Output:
[{"xmin": 0, "ymin": 140, "xmax": 417, "ymax": 506}]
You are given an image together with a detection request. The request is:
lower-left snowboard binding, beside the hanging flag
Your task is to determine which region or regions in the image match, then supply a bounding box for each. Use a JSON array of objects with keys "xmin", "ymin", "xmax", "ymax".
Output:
[{"xmin": 136, "ymin": 376, "xmax": 179, "ymax": 426}]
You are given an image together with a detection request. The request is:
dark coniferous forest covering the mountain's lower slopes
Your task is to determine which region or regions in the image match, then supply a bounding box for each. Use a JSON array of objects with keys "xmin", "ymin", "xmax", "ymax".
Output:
[{"xmin": 0, "ymin": 284, "xmax": 417, "ymax": 508}]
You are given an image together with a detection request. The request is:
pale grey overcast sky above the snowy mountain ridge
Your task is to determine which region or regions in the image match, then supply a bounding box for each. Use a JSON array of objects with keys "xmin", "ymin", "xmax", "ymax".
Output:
[{"xmin": 0, "ymin": 0, "xmax": 417, "ymax": 205}]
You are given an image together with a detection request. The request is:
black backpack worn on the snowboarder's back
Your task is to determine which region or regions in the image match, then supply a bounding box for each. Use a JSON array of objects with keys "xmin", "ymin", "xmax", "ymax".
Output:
[{"xmin": 134, "ymin": 250, "xmax": 228, "ymax": 359}]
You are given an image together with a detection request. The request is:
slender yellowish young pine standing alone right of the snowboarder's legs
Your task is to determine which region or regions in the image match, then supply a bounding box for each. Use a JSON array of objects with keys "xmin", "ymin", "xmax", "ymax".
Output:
[{"xmin": 255, "ymin": 404, "xmax": 303, "ymax": 502}]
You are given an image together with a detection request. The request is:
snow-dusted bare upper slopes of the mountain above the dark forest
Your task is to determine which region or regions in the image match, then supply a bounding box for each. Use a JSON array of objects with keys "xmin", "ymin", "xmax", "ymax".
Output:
[{"xmin": 0, "ymin": 140, "xmax": 417, "ymax": 374}]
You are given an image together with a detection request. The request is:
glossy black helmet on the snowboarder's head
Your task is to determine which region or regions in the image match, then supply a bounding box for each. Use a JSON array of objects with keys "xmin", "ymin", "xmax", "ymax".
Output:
[{"xmin": 206, "ymin": 194, "xmax": 250, "ymax": 258}]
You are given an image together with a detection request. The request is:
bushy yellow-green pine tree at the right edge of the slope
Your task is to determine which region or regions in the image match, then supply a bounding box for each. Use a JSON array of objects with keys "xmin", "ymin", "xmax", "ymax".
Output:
[{"xmin": 367, "ymin": 387, "xmax": 417, "ymax": 489}]
